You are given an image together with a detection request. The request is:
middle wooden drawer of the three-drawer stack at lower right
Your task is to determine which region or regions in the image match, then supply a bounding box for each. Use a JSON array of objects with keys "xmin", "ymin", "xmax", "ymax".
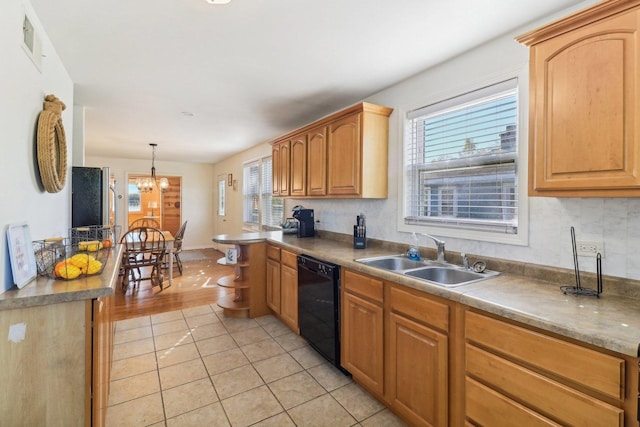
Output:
[{"xmin": 465, "ymin": 344, "xmax": 624, "ymax": 427}]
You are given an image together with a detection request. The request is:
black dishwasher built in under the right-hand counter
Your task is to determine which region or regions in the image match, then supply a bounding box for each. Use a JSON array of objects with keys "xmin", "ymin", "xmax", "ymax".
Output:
[{"xmin": 298, "ymin": 255, "xmax": 344, "ymax": 371}]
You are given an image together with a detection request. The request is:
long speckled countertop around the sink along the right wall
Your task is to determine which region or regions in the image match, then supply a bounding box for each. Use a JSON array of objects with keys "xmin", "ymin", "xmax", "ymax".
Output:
[{"xmin": 213, "ymin": 232, "xmax": 640, "ymax": 357}]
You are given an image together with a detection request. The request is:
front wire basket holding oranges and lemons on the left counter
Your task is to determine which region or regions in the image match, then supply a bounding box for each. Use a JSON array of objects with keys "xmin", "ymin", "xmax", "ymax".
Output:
[{"xmin": 33, "ymin": 238, "xmax": 111, "ymax": 280}]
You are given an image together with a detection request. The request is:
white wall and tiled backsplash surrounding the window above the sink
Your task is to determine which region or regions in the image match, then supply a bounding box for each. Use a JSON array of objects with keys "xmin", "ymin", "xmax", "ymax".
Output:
[{"xmin": 216, "ymin": 1, "xmax": 640, "ymax": 279}]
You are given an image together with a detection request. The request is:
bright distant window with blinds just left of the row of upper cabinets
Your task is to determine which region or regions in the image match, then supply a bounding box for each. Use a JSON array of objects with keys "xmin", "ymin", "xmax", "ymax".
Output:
[{"xmin": 242, "ymin": 157, "xmax": 284, "ymax": 230}]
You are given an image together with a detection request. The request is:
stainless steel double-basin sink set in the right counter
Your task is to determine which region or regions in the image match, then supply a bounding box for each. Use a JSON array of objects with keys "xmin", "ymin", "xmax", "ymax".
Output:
[{"xmin": 355, "ymin": 255, "xmax": 500, "ymax": 287}]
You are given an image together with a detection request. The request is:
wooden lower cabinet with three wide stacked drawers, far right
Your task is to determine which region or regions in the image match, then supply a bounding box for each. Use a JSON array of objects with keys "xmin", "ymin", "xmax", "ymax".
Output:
[{"xmin": 465, "ymin": 311, "xmax": 638, "ymax": 427}]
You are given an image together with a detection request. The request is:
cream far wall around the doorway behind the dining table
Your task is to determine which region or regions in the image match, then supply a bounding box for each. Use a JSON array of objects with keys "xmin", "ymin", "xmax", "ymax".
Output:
[{"xmin": 85, "ymin": 156, "xmax": 216, "ymax": 249}]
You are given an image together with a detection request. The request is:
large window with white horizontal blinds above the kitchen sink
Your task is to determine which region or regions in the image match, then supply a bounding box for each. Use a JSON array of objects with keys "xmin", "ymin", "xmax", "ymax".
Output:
[{"xmin": 404, "ymin": 79, "xmax": 518, "ymax": 234}]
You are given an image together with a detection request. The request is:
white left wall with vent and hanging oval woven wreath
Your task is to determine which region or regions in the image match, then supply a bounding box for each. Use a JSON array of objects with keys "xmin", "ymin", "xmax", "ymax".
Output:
[{"xmin": 0, "ymin": 0, "xmax": 73, "ymax": 293}]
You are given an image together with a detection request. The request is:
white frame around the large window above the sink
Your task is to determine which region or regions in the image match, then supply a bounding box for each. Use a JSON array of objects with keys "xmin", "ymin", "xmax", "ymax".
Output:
[{"xmin": 396, "ymin": 68, "xmax": 529, "ymax": 246}]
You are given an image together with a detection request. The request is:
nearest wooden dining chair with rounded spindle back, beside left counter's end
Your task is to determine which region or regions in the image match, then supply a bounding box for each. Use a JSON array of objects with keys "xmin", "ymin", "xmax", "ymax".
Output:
[{"xmin": 120, "ymin": 227, "xmax": 166, "ymax": 292}]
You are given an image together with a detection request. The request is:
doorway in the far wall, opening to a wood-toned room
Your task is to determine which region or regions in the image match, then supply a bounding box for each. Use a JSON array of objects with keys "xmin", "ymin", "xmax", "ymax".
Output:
[{"xmin": 126, "ymin": 175, "xmax": 182, "ymax": 234}]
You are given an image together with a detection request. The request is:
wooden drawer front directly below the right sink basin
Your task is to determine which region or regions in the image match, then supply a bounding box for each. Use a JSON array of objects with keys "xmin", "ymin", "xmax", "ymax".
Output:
[{"xmin": 389, "ymin": 286, "xmax": 449, "ymax": 331}]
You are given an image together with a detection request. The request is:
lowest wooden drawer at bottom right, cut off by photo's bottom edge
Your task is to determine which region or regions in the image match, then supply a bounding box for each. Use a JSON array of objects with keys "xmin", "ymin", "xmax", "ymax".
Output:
[{"xmin": 465, "ymin": 377, "xmax": 560, "ymax": 427}]
